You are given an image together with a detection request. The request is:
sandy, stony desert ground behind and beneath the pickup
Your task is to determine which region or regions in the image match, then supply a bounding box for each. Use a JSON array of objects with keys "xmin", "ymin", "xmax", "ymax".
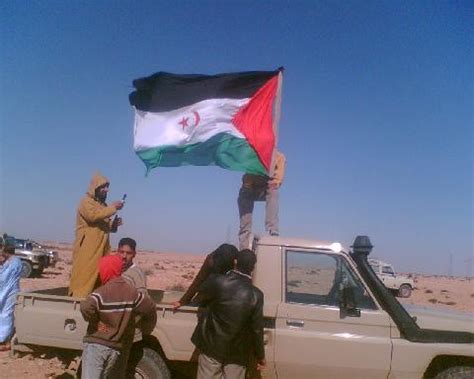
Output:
[{"xmin": 0, "ymin": 242, "xmax": 474, "ymax": 379}]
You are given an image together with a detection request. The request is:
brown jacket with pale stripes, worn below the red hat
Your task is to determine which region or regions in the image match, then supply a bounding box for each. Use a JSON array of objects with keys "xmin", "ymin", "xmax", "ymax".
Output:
[{"xmin": 81, "ymin": 277, "xmax": 156, "ymax": 349}]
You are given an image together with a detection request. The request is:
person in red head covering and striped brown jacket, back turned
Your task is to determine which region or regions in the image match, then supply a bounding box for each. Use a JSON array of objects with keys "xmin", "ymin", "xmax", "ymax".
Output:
[{"xmin": 81, "ymin": 255, "xmax": 156, "ymax": 379}]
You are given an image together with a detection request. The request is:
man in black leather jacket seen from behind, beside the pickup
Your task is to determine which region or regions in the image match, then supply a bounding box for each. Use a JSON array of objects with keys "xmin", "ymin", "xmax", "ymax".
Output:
[{"xmin": 191, "ymin": 249, "xmax": 265, "ymax": 379}]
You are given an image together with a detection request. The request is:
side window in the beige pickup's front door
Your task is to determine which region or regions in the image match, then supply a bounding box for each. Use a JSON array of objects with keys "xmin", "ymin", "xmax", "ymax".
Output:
[{"xmin": 285, "ymin": 250, "xmax": 377, "ymax": 309}]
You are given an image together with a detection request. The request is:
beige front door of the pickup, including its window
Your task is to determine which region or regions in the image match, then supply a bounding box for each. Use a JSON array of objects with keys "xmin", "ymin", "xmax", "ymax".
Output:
[{"xmin": 275, "ymin": 250, "xmax": 392, "ymax": 379}]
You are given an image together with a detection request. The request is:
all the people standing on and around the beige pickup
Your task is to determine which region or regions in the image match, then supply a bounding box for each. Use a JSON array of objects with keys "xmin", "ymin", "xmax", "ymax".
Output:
[{"xmin": 0, "ymin": 152, "xmax": 285, "ymax": 379}]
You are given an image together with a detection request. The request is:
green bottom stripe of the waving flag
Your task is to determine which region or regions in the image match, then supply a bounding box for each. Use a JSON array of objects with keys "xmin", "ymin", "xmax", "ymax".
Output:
[{"xmin": 136, "ymin": 133, "xmax": 267, "ymax": 175}]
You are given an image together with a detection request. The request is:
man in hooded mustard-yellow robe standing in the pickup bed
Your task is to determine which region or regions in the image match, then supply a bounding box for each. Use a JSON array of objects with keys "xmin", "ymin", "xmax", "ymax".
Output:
[{"xmin": 69, "ymin": 173, "xmax": 124, "ymax": 297}]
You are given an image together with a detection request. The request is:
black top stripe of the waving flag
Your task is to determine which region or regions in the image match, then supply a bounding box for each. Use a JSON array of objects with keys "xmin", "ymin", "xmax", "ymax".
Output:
[{"xmin": 129, "ymin": 70, "xmax": 279, "ymax": 112}]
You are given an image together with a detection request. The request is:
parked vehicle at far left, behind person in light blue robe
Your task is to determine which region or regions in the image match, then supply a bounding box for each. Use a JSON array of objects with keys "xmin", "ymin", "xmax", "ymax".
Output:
[{"xmin": 4, "ymin": 236, "xmax": 58, "ymax": 278}]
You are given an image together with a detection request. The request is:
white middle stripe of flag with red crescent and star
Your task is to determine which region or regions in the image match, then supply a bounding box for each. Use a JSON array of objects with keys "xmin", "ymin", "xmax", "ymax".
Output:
[{"xmin": 133, "ymin": 98, "xmax": 250, "ymax": 151}]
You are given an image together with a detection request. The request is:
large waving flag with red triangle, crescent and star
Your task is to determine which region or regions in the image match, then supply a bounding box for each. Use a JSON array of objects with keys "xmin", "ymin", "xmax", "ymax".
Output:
[{"xmin": 130, "ymin": 69, "xmax": 282, "ymax": 175}]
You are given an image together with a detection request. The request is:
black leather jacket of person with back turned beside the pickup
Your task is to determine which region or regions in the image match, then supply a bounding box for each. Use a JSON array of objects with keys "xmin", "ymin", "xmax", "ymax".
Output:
[{"xmin": 191, "ymin": 271, "xmax": 265, "ymax": 366}]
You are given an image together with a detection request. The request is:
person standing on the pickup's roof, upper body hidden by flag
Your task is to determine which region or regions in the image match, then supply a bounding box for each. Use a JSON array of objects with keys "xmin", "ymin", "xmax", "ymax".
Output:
[{"xmin": 237, "ymin": 150, "xmax": 286, "ymax": 250}]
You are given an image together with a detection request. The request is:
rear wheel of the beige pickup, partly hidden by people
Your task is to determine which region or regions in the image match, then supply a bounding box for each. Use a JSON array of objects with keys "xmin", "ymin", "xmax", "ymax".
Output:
[{"xmin": 127, "ymin": 347, "xmax": 171, "ymax": 379}]
